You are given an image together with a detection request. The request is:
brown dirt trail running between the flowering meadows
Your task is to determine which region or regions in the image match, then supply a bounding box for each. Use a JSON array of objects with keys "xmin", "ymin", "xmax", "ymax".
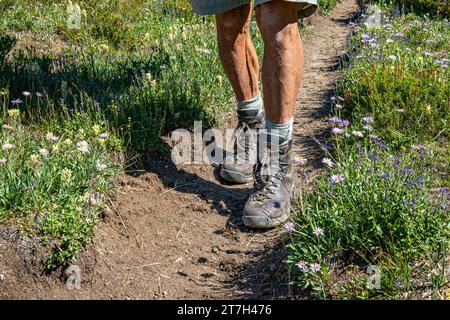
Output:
[{"xmin": 0, "ymin": 0, "xmax": 357, "ymax": 299}]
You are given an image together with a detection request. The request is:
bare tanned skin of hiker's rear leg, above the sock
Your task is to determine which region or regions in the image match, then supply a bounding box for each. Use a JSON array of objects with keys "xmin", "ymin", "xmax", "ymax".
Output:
[{"xmin": 216, "ymin": 4, "xmax": 259, "ymax": 101}]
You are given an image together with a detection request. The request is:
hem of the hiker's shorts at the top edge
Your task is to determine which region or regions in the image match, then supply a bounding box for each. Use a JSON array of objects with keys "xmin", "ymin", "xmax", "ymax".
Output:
[{"xmin": 191, "ymin": 0, "xmax": 317, "ymax": 19}]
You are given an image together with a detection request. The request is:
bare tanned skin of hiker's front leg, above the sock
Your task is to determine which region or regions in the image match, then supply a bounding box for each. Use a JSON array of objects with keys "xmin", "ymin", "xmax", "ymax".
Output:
[{"xmin": 256, "ymin": 0, "xmax": 304, "ymax": 124}]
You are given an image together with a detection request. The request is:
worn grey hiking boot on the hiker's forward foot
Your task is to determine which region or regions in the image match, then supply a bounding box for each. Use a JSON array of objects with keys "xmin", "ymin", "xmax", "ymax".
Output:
[{"xmin": 242, "ymin": 141, "xmax": 295, "ymax": 229}]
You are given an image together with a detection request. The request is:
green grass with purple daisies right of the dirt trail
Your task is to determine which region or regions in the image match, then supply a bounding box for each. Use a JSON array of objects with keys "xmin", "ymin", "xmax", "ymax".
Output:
[{"xmin": 288, "ymin": 10, "xmax": 450, "ymax": 299}]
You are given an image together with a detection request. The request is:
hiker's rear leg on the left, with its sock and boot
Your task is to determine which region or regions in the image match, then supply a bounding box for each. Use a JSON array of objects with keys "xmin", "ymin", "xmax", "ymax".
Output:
[{"xmin": 216, "ymin": 4, "xmax": 264, "ymax": 183}]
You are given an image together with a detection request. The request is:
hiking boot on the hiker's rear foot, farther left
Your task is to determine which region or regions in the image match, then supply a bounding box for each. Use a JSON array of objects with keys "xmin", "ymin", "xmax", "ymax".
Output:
[{"xmin": 220, "ymin": 111, "xmax": 265, "ymax": 184}]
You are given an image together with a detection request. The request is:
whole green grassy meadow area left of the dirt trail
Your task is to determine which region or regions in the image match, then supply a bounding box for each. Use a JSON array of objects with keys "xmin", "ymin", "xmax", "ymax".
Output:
[{"xmin": 0, "ymin": 0, "xmax": 241, "ymax": 269}]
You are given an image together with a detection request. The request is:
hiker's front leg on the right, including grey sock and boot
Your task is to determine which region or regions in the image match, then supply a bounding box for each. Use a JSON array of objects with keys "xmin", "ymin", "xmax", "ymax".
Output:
[{"xmin": 243, "ymin": 0, "xmax": 303, "ymax": 228}]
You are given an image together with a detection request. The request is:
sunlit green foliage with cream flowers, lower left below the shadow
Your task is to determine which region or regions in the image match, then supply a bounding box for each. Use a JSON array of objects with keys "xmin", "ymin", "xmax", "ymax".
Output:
[{"xmin": 0, "ymin": 97, "xmax": 122, "ymax": 269}]
